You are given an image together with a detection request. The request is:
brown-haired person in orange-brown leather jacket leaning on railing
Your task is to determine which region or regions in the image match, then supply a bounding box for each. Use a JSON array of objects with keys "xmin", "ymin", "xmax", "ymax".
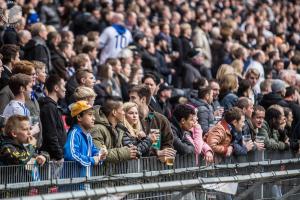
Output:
[{"xmin": 205, "ymin": 107, "xmax": 247, "ymax": 161}]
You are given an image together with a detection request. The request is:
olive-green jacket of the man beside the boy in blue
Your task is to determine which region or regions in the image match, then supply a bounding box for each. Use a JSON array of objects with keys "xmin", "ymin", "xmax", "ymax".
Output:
[{"xmin": 91, "ymin": 107, "xmax": 131, "ymax": 162}]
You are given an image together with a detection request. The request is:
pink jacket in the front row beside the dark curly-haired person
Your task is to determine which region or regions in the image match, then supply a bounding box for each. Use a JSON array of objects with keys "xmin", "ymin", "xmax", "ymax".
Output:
[{"xmin": 187, "ymin": 124, "xmax": 213, "ymax": 165}]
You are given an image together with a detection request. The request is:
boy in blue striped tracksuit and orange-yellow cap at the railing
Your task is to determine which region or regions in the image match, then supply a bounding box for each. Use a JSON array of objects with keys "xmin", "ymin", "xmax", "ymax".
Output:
[{"xmin": 64, "ymin": 101, "xmax": 107, "ymax": 182}]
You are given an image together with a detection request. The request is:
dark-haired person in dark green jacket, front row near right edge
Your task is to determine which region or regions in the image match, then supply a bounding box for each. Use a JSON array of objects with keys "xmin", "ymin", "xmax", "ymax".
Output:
[{"xmin": 258, "ymin": 105, "xmax": 290, "ymax": 150}]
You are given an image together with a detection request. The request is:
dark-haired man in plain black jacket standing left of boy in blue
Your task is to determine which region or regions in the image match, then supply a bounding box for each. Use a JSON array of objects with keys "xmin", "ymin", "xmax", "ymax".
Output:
[{"xmin": 40, "ymin": 75, "xmax": 67, "ymax": 162}]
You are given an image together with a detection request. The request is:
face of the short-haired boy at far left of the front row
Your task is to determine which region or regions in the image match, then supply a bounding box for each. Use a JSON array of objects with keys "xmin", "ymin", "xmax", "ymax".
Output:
[{"xmin": 12, "ymin": 121, "xmax": 31, "ymax": 144}]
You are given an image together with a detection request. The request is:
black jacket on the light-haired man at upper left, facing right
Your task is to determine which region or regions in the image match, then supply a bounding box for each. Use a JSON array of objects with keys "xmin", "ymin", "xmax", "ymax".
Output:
[{"xmin": 24, "ymin": 36, "xmax": 52, "ymax": 72}]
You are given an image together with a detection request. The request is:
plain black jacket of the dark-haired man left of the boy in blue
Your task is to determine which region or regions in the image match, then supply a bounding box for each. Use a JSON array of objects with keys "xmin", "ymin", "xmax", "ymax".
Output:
[{"xmin": 40, "ymin": 97, "xmax": 67, "ymax": 160}]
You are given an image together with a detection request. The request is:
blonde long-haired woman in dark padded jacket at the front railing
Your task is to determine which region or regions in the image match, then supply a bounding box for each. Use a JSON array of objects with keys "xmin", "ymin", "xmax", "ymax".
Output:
[{"xmin": 123, "ymin": 102, "xmax": 157, "ymax": 156}]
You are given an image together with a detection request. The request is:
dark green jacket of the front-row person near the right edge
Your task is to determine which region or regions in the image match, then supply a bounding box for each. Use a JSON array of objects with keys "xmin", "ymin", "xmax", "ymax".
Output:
[{"xmin": 258, "ymin": 121, "xmax": 288, "ymax": 150}]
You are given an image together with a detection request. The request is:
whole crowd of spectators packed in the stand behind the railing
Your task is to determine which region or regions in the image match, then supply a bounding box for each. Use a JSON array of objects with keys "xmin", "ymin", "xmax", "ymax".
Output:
[{"xmin": 0, "ymin": 0, "xmax": 300, "ymax": 185}]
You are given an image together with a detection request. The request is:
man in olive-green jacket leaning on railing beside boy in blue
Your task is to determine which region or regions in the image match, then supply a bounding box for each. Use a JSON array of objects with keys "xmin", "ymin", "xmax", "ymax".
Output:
[{"xmin": 91, "ymin": 100, "xmax": 138, "ymax": 162}]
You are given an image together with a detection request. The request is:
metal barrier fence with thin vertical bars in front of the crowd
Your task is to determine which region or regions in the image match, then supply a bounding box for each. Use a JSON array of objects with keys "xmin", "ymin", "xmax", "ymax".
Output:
[{"xmin": 0, "ymin": 151, "xmax": 300, "ymax": 199}]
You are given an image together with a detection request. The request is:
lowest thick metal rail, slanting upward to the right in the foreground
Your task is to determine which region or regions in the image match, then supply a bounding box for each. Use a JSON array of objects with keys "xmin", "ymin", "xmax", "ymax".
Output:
[{"xmin": 8, "ymin": 170, "xmax": 300, "ymax": 200}]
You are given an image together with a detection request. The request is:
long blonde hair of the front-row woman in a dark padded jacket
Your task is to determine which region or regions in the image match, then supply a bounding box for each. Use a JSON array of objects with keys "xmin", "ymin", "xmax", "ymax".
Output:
[{"xmin": 123, "ymin": 102, "xmax": 142, "ymax": 137}]
